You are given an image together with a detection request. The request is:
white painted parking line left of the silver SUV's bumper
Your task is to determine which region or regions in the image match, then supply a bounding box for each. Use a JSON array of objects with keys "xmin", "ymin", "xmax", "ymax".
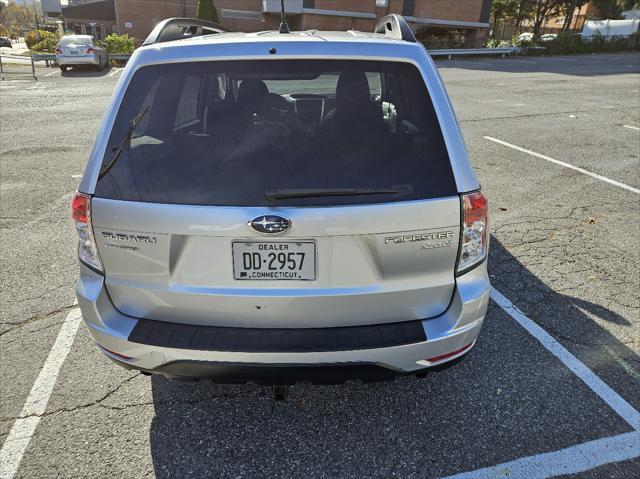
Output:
[{"xmin": 0, "ymin": 308, "xmax": 82, "ymax": 479}]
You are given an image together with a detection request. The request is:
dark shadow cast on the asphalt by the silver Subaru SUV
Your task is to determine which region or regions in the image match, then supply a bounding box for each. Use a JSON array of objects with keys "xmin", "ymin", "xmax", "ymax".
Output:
[{"xmin": 150, "ymin": 238, "xmax": 640, "ymax": 479}]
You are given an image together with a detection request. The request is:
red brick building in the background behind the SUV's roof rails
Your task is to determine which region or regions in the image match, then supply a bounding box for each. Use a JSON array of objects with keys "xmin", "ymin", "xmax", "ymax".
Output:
[{"xmin": 63, "ymin": 0, "xmax": 491, "ymax": 46}]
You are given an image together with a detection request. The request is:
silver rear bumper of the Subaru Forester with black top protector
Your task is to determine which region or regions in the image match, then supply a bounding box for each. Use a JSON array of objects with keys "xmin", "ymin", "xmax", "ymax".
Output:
[{"xmin": 76, "ymin": 263, "xmax": 490, "ymax": 384}]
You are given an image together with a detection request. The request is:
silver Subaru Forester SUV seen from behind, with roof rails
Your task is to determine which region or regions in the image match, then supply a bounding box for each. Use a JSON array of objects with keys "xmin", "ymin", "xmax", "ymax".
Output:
[{"xmin": 73, "ymin": 15, "xmax": 490, "ymax": 385}]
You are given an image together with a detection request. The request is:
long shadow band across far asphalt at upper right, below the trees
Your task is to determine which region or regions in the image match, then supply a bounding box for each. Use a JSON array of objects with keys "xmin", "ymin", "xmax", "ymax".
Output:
[{"xmin": 434, "ymin": 51, "xmax": 640, "ymax": 77}]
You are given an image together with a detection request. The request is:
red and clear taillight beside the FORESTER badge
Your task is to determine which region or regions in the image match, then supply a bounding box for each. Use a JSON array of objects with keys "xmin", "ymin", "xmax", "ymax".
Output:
[{"xmin": 457, "ymin": 191, "xmax": 489, "ymax": 274}]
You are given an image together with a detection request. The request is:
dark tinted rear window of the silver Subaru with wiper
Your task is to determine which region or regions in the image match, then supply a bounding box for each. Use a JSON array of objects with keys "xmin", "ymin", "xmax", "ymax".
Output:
[{"xmin": 96, "ymin": 60, "xmax": 456, "ymax": 206}]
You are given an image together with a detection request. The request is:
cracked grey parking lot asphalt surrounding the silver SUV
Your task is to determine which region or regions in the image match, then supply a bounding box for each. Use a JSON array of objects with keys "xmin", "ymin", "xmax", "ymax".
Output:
[{"xmin": 0, "ymin": 53, "xmax": 640, "ymax": 478}]
